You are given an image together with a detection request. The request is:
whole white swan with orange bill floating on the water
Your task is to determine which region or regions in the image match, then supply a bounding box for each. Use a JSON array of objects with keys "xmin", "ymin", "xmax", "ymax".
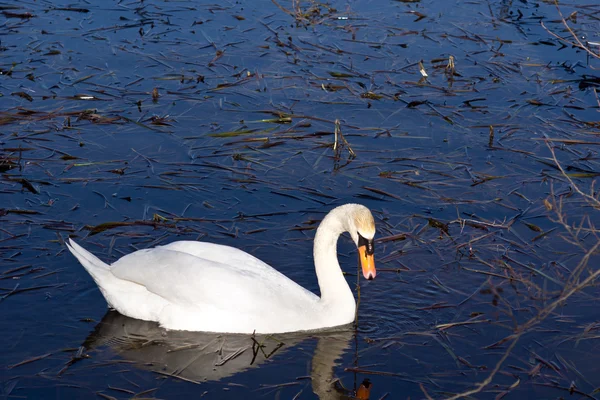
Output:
[{"xmin": 67, "ymin": 204, "xmax": 375, "ymax": 333}]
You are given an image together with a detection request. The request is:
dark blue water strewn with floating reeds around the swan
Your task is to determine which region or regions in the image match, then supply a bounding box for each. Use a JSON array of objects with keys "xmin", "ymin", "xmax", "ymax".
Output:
[{"xmin": 0, "ymin": 1, "xmax": 600, "ymax": 399}]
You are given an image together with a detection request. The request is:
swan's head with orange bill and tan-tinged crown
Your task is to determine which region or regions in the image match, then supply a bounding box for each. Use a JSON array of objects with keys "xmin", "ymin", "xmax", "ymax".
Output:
[{"xmin": 348, "ymin": 204, "xmax": 376, "ymax": 280}]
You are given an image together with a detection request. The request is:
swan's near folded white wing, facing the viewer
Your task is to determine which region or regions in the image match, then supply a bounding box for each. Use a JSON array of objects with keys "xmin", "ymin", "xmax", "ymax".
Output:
[{"xmin": 111, "ymin": 247, "xmax": 316, "ymax": 313}]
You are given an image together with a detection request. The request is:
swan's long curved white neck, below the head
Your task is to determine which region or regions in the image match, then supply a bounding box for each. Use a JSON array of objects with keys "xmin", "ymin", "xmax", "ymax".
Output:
[{"xmin": 313, "ymin": 205, "xmax": 356, "ymax": 313}]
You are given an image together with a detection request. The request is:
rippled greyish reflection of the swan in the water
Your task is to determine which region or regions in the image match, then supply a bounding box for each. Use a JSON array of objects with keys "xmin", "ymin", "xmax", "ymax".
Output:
[{"xmin": 83, "ymin": 311, "xmax": 371, "ymax": 400}]
